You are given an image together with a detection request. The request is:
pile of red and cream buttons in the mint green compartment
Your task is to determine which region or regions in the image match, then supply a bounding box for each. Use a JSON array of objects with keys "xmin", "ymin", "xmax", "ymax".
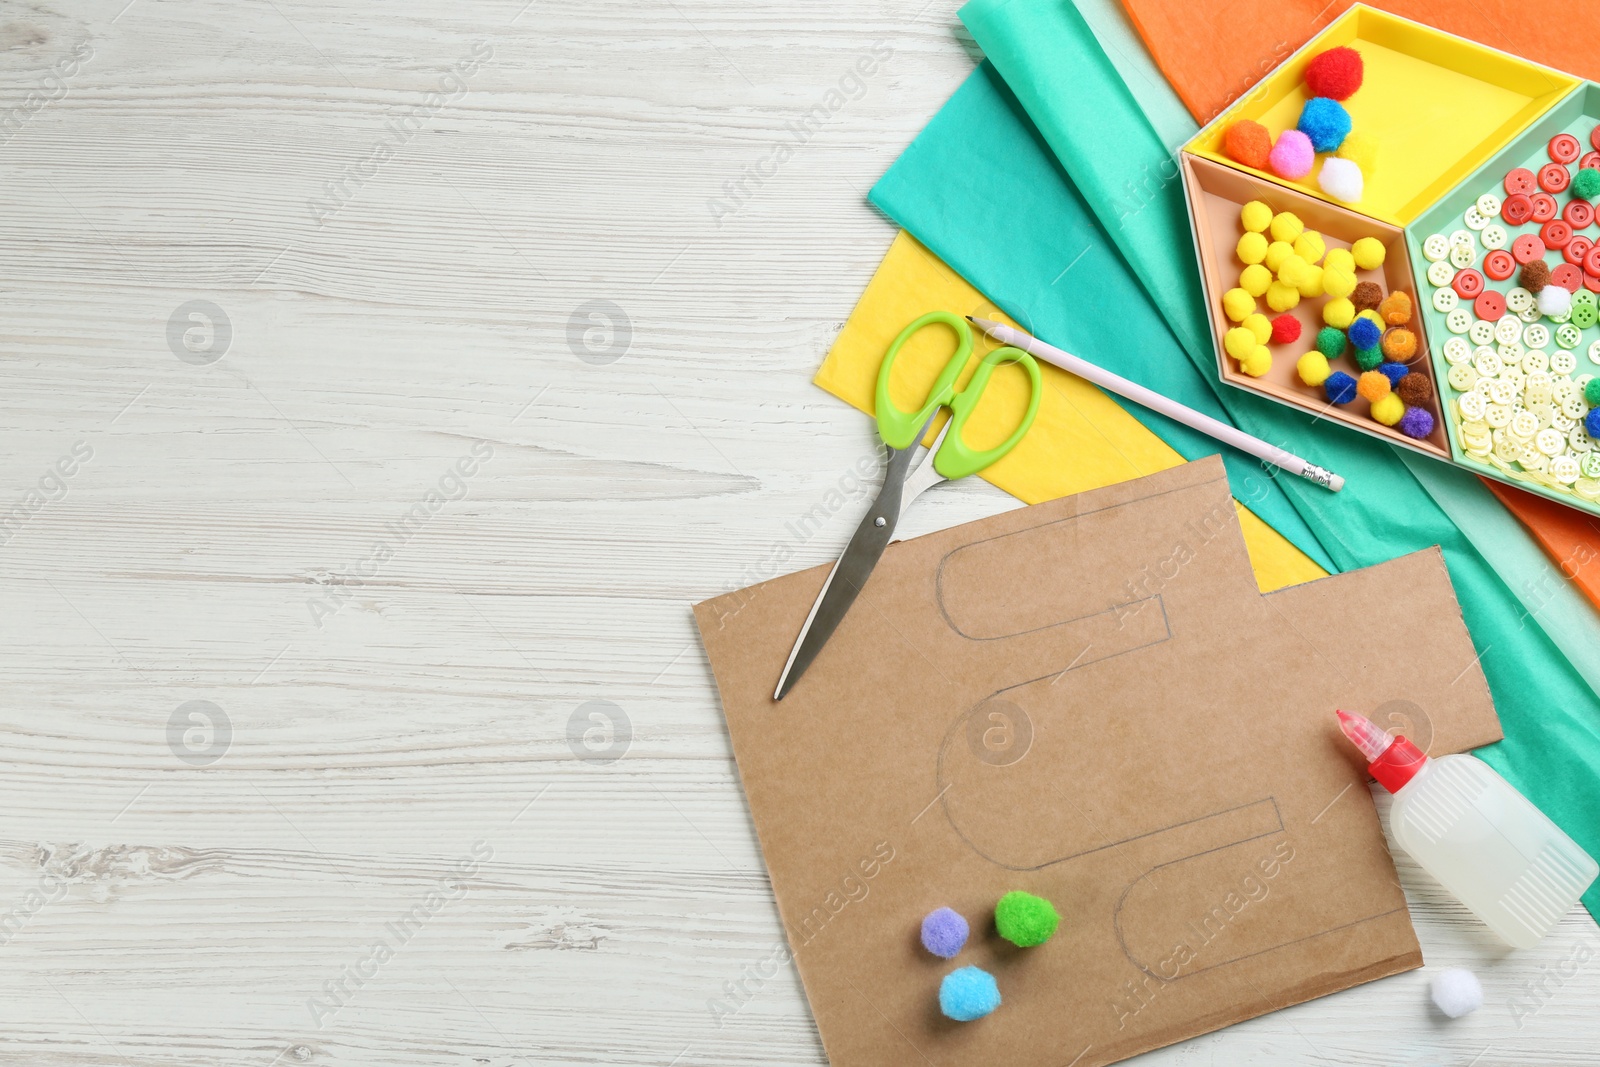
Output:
[{"xmin": 1422, "ymin": 126, "xmax": 1600, "ymax": 501}]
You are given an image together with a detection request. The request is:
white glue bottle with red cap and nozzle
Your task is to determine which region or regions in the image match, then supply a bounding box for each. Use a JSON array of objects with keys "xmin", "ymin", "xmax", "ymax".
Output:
[{"xmin": 1339, "ymin": 712, "xmax": 1600, "ymax": 949}]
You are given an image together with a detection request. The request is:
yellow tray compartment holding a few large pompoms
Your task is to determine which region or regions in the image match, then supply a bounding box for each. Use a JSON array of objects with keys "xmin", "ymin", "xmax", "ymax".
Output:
[{"xmin": 1184, "ymin": 5, "xmax": 1579, "ymax": 226}]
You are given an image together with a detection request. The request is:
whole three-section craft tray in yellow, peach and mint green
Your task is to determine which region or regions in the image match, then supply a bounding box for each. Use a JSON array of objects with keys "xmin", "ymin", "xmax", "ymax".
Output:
[{"xmin": 1179, "ymin": 5, "xmax": 1600, "ymax": 514}]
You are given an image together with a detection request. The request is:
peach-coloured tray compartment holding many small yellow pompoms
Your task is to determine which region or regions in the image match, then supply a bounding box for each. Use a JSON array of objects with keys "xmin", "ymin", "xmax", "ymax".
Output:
[{"xmin": 1182, "ymin": 154, "xmax": 1450, "ymax": 459}]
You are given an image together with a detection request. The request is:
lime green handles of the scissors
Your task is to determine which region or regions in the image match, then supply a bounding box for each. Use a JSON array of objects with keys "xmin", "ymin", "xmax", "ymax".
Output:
[{"xmin": 877, "ymin": 312, "xmax": 1043, "ymax": 478}]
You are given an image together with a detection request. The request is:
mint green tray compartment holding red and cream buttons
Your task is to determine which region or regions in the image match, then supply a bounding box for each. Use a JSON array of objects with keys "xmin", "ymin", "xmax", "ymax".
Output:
[{"xmin": 1406, "ymin": 82, "xmax": 1600, "ymax": 510}]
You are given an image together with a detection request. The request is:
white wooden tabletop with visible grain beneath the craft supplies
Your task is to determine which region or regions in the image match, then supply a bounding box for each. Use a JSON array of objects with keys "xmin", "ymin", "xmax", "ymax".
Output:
[{"xmin": 0, "ymin": 0, "xmax": 1600, "ymax": 1067}]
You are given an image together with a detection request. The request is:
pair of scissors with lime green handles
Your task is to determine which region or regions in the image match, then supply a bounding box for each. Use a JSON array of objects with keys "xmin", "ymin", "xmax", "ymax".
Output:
[{"xmin": 773, "ymin": 312, "xmax": 1042, "ymax": 701}]
